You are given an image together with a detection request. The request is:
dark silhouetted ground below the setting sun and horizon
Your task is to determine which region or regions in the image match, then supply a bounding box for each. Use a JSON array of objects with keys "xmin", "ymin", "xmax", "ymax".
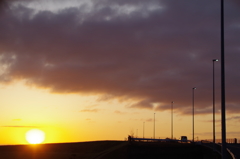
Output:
[{"xmin": 0, "ymin": 141, "xmax": 220, "ymax": 159}]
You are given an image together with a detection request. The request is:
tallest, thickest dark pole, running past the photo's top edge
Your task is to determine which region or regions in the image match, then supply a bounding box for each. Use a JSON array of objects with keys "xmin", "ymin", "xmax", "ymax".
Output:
[{"xmin": 221, "ymin": 0, "xmax": 227, "ymax": 159}]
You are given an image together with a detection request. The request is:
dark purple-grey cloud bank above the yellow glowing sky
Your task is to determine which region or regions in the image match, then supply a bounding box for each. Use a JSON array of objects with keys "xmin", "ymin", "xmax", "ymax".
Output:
[{"xmin": 0, "ymin": 0, "xmax": 240, "ymax": 114}]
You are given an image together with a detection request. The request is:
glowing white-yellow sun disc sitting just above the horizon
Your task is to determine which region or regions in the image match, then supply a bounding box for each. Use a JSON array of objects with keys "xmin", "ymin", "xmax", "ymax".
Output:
[{"xmin": 26, "ymin": 129, "xmax": 45, "ymax": 144}]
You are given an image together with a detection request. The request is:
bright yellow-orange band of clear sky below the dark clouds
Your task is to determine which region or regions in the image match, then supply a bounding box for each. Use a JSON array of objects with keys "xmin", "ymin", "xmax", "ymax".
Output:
[{"xmin": 0, "ymin": 82, "xmax": 237, "ymax": 145}]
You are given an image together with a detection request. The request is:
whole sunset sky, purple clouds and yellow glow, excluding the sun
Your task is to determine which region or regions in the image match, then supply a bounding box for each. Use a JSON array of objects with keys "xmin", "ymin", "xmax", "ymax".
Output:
[{"xmin": 0, "ymin": 0, "xmax": 240, "ymax": 144}]
